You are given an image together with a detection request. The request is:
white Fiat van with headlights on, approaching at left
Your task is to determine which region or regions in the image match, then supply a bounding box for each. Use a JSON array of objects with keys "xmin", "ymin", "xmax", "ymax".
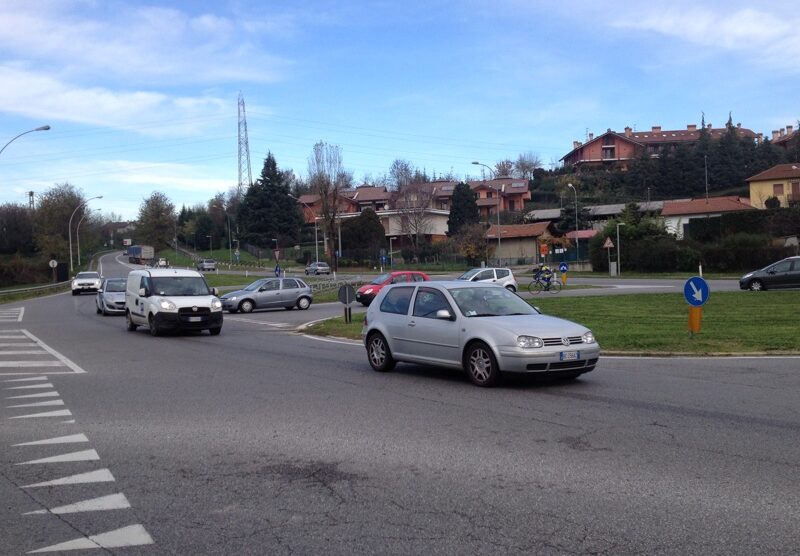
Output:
[{"xmin": 125, "ymin": 268, "xmax": 222, "ymax": 336}]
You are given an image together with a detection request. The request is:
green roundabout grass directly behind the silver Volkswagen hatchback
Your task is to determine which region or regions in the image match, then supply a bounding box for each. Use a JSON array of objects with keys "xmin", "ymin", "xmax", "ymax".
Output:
[{"xmin": 307, "ymin": 291, "xmax": 800, "ymax": 355}]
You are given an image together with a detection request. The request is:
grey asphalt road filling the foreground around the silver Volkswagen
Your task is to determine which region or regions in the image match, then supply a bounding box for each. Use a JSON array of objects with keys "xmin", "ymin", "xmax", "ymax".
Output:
[{"xmin": 0, "ymin": 254, "xmax": 800, "ymax": 554}]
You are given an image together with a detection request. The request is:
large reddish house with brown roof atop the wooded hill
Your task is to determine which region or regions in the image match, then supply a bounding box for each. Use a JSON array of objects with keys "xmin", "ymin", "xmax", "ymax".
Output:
[{"xmin": 561, "ymin": 124, "xmax": 761, "ymax": 170}]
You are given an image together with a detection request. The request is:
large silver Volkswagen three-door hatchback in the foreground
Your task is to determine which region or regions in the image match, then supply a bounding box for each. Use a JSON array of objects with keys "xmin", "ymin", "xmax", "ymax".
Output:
[{"xmin": 362, "ymin": 281, "xmax": 600, "ymax": 386}]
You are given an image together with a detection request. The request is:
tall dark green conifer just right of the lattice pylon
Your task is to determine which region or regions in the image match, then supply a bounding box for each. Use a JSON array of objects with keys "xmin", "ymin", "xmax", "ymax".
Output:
[{"xmin": 238, "ymin": 152, "xmax": 303, "ymax": 248}]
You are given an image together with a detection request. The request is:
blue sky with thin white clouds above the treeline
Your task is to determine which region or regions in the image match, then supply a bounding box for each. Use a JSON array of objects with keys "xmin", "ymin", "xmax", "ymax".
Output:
[{"xmin": 0, "ymin": 0, "xmax": 800, "ymax": 219}]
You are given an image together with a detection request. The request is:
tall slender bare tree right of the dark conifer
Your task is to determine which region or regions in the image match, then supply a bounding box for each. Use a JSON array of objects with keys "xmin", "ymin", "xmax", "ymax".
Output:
[{"xmin": 308, "ymin": 141, "xmax": 352, "ymax": 269}]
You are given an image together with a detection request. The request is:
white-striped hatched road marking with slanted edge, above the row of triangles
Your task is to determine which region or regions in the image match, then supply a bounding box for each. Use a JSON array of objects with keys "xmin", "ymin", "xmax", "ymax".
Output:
[{"xmin": 0, "ymin": 328, "xmax": 86, "ymax": 376}]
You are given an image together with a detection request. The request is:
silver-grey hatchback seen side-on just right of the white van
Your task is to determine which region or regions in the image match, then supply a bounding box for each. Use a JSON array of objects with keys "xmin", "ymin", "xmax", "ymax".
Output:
[{"xmin": 221, "ymin": 278, "xmax": 314, "ymax": 313}]
